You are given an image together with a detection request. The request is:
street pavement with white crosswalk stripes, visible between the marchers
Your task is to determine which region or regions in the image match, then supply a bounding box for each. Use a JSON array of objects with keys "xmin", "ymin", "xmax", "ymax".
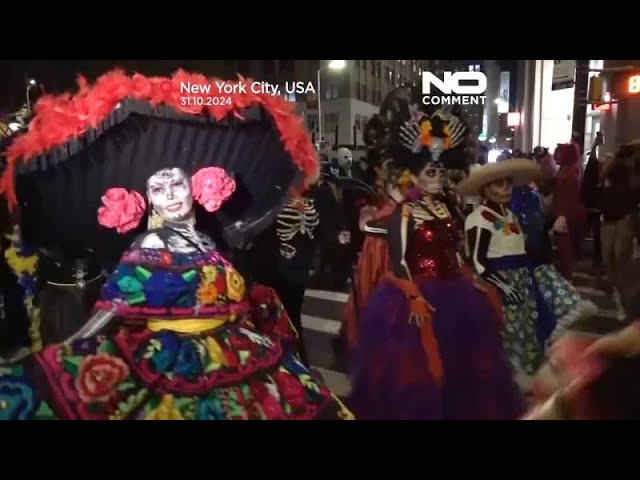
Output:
[{"xmin": 302, "ymin": 253, "xmax": 623, "ymax": 396}]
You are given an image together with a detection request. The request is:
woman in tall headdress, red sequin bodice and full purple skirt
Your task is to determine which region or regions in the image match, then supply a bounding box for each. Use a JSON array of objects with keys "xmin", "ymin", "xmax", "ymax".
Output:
[{"xmin": 350, "ymin": 88, "xmax": 522, "ymax": 420}]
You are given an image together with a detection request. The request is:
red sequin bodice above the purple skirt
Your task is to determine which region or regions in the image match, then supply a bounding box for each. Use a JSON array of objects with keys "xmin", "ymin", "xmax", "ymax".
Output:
[{"xmin": 405, "ymin": 218, "xmax": 460, "ymax": 278}]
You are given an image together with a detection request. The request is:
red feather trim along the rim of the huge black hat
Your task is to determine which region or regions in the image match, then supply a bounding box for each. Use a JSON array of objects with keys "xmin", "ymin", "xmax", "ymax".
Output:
[{"xmin": 0, "ymin": 70, "xmax": 319, "ymax": 208}]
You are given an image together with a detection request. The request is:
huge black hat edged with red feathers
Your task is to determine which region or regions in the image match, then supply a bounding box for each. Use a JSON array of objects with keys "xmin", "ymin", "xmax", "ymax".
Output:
[{"xmin": 0, "ymin": 70, "xmax": 318, "ymax": 256}]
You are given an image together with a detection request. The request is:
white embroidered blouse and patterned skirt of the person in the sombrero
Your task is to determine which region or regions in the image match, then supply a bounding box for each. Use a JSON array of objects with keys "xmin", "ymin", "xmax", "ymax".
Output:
[{"xmin": 465, "ymin": 204, "xmax": 596, "ymax": 379}]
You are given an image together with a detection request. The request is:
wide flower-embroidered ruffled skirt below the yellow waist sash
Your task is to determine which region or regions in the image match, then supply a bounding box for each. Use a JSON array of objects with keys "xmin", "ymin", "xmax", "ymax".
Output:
[{"xmin": 0, "ymin": 324, "xmax": 353, "ymax": 420}]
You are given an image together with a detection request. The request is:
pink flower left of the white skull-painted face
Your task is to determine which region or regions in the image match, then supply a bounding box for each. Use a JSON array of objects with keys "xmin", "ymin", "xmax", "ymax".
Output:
[{"xmin": 98, "ymin": 188, "xmax": 146, "ymax": 233}]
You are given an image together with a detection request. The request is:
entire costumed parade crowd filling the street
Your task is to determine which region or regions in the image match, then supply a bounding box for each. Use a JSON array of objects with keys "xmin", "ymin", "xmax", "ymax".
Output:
[{"xmin": 0, "ymin": 71, "xmax": 640, "ymax": 420}]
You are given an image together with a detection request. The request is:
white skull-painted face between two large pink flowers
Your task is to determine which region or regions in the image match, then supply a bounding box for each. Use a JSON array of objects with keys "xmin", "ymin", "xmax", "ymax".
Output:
[{"xmin": 147, "ymin": 168, "xmax": 193, "ymax": 221}]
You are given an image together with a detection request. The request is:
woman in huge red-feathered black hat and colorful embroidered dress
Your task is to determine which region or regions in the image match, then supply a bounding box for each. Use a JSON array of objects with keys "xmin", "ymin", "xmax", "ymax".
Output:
[{"xmin": 0, "ymin": 71, "xmax": 352, "ymax": 420}]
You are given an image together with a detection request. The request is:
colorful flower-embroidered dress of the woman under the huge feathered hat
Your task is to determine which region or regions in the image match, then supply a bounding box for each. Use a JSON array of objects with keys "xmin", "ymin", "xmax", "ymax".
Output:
[{"xmin": 0, "ymin": 240, "xmax": 351, "ymax": 420}]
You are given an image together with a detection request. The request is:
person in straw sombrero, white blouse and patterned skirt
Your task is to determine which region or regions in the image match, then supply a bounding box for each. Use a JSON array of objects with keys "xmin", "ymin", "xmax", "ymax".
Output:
[{"xmin": 457, "ymin": 158, "xmax": 582, "ymax": 389}]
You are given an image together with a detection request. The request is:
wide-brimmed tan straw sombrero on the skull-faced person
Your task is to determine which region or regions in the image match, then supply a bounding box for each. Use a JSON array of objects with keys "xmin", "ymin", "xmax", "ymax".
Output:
[{"xmin": 456, "ymin": 158, "xmax": 542, "ymax": 196}]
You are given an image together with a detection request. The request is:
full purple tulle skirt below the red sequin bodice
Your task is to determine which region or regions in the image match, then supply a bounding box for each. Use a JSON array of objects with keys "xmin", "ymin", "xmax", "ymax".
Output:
[{"xmin": 349, "ymin": 276, "xmax": 524, "ymax": 420}]
